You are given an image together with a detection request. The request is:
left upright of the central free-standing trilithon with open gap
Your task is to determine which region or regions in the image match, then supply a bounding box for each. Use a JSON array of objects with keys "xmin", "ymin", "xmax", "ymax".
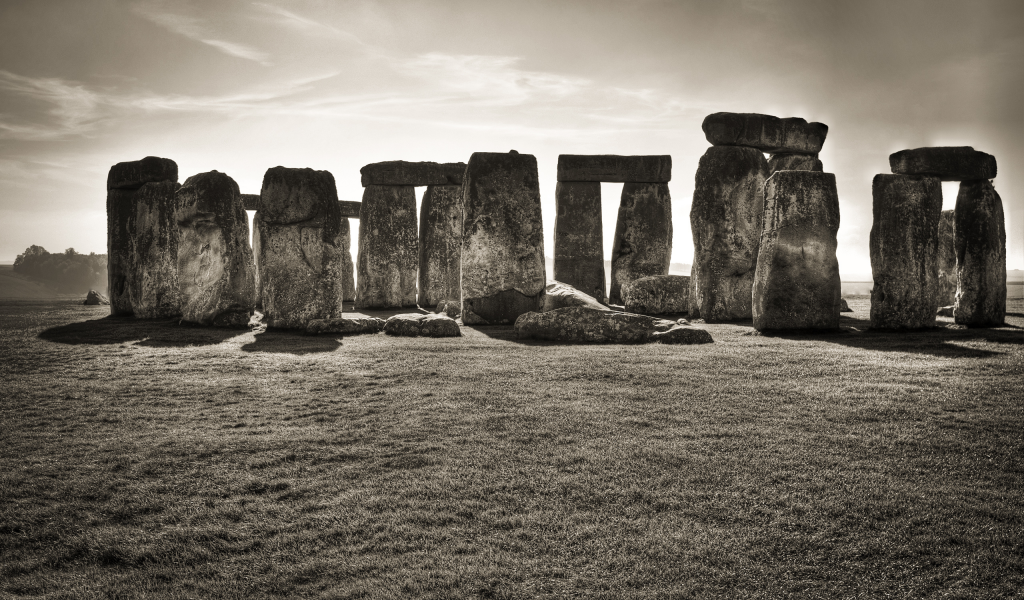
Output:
[{"xmin": 554, "ymin": 181, "xmax": 607, "ymax": 302}]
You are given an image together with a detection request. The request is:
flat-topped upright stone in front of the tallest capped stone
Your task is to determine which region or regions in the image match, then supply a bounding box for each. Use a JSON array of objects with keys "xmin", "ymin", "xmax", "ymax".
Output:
[{"xmin": 753, "ymin": 171, "xmax": 843, "ymax": 331}]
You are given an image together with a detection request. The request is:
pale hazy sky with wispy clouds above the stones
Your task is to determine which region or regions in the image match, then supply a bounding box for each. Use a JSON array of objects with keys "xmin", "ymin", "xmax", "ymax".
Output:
[{"xmin": 0, "ymin": 0, "xmax": 1024, "ymax": 280}]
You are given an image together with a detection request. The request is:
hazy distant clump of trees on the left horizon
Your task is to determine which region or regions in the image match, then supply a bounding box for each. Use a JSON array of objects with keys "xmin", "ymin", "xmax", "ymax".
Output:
[{"xmin": 14, "ymin": 246, "xmax": 106, "ymax": 294}]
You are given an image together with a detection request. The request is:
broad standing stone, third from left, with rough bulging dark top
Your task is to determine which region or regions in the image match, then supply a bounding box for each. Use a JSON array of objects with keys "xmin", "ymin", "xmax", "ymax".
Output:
[{"xmin": 253, "ymin": 167, "xmax": 348, "ymax": 329}]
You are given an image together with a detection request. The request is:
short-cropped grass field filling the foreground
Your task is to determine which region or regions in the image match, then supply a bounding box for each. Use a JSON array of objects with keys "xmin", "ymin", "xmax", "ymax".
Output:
[{"xmin": 0, "ymin": 298, "xmax": 1024, "ymax": 599}]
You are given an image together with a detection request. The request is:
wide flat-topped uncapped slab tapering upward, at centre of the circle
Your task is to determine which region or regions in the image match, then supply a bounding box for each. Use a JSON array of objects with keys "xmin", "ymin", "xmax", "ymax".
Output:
[{"xmin": 462, "ymin": 151, "xmax": 547, "ymax": 325}]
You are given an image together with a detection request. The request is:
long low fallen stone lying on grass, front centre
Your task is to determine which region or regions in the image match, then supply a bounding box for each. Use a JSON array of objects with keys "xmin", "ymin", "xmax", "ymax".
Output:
[{"xmin": 515, "ymin": 306, "xmax": 712, "ymax": 344}]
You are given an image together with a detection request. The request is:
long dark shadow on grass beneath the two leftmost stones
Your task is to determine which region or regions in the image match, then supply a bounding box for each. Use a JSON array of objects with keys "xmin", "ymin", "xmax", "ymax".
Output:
[{"xmin": 38, "ymin": 316, "xmax": 237, "ymax": 347}]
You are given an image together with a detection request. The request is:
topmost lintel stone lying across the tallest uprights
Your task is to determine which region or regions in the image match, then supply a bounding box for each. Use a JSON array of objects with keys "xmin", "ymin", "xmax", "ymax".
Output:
[{"xmin": 700, "ymin": 113, "xmax": 828, "ymax": 155}]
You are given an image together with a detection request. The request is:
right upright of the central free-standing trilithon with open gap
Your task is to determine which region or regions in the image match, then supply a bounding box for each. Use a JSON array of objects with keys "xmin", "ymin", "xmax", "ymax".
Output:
[{"xmin": 608, "ymin": 183, "xmax": 672, "ymax": 304}]
